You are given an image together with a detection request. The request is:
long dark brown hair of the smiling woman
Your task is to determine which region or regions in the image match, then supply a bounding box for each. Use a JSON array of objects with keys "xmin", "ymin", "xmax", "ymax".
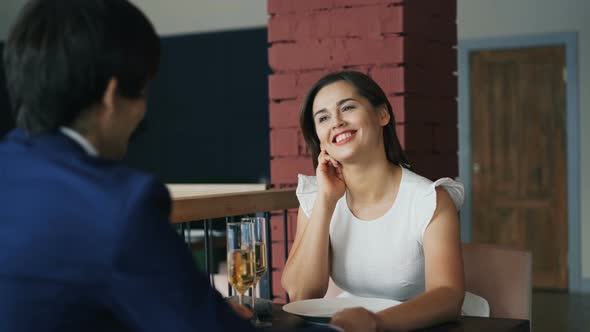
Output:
[{"xmin": 299, "ymin": 71, "xmax": 411, "ymax": 169}]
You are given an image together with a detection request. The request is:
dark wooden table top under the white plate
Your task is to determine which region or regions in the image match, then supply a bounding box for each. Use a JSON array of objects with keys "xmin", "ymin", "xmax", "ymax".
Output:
[{"xmin": 271, "ymin": 304, "xmax": 530, "ymax": 332}]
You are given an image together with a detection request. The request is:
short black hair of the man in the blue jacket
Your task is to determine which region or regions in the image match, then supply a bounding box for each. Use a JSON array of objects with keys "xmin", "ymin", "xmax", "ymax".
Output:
[{"xmin": 4, "ymin": 0, "xmax": 160, "ymax": 134}]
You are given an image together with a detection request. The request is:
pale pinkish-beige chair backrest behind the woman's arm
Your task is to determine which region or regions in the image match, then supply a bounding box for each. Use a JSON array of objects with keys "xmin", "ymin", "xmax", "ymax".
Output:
[{"xmin": 463, "ymin": 243, "xmax": 532, "ymax": 320}]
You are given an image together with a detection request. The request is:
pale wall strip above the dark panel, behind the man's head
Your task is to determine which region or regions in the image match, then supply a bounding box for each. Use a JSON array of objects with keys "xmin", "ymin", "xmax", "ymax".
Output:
[{"xmin": 0, "ymin": 0, "xmax": 268, "ymax": 41}]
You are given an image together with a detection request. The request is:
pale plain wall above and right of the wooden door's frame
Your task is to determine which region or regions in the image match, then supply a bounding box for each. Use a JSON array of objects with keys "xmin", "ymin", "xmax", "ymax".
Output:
[{"xmin": 457, "ymin": 0, "xmax": 590, "ymax": 278}]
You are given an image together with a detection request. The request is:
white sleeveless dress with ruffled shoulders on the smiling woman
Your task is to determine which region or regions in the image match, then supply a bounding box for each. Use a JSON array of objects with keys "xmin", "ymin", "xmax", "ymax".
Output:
[{"xmin": 296, "ymin": 168, "xmax": 489, "ymax": 316}]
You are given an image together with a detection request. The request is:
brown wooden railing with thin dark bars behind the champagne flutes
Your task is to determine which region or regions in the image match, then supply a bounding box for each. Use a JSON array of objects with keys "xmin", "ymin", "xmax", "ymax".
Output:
[{"xmin": 168, "ymin": 184, "xmax": 299, "ymax": 300}]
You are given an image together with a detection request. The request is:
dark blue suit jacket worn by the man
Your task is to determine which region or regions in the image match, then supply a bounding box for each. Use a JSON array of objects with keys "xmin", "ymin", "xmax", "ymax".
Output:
[{"xmin": 0, "ymin": 129, "xmax": 260, "ymax": 332}]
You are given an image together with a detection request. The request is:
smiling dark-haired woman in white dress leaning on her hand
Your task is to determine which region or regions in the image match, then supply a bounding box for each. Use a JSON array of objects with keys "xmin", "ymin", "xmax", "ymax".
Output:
[{"xmin": 282, "ymin": 71, "xmax": 472, "ymax": 331}]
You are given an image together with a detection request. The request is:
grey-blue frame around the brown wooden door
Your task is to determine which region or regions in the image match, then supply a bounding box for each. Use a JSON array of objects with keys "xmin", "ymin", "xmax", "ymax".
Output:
[{"xmin": 458, "ymin": 32, "xmax": 590, "ymax": 292}]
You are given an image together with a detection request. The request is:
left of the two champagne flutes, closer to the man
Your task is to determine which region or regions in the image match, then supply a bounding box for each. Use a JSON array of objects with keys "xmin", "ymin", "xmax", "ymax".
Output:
[{"xmin": 227, "ymin": 222, "xmax": 256, "ymax": 305}]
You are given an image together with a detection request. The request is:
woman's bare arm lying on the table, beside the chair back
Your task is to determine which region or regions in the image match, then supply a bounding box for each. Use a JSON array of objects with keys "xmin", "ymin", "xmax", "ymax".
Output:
[{"xmin": 332, "ymin": 188, "xmax": 465, "ymax": 332}]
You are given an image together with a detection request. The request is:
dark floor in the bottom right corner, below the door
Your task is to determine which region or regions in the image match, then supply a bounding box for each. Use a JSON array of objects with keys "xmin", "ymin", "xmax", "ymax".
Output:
[{"xmin": 532, "ymin": 291, "xmax": 590, "ymax": 332}]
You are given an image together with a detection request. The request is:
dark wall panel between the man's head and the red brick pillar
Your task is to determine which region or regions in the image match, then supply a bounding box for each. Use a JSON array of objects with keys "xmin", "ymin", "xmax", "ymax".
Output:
[{"xmin": 127, "ymin": 28, "xmax": 270, "ymax": 183}]
